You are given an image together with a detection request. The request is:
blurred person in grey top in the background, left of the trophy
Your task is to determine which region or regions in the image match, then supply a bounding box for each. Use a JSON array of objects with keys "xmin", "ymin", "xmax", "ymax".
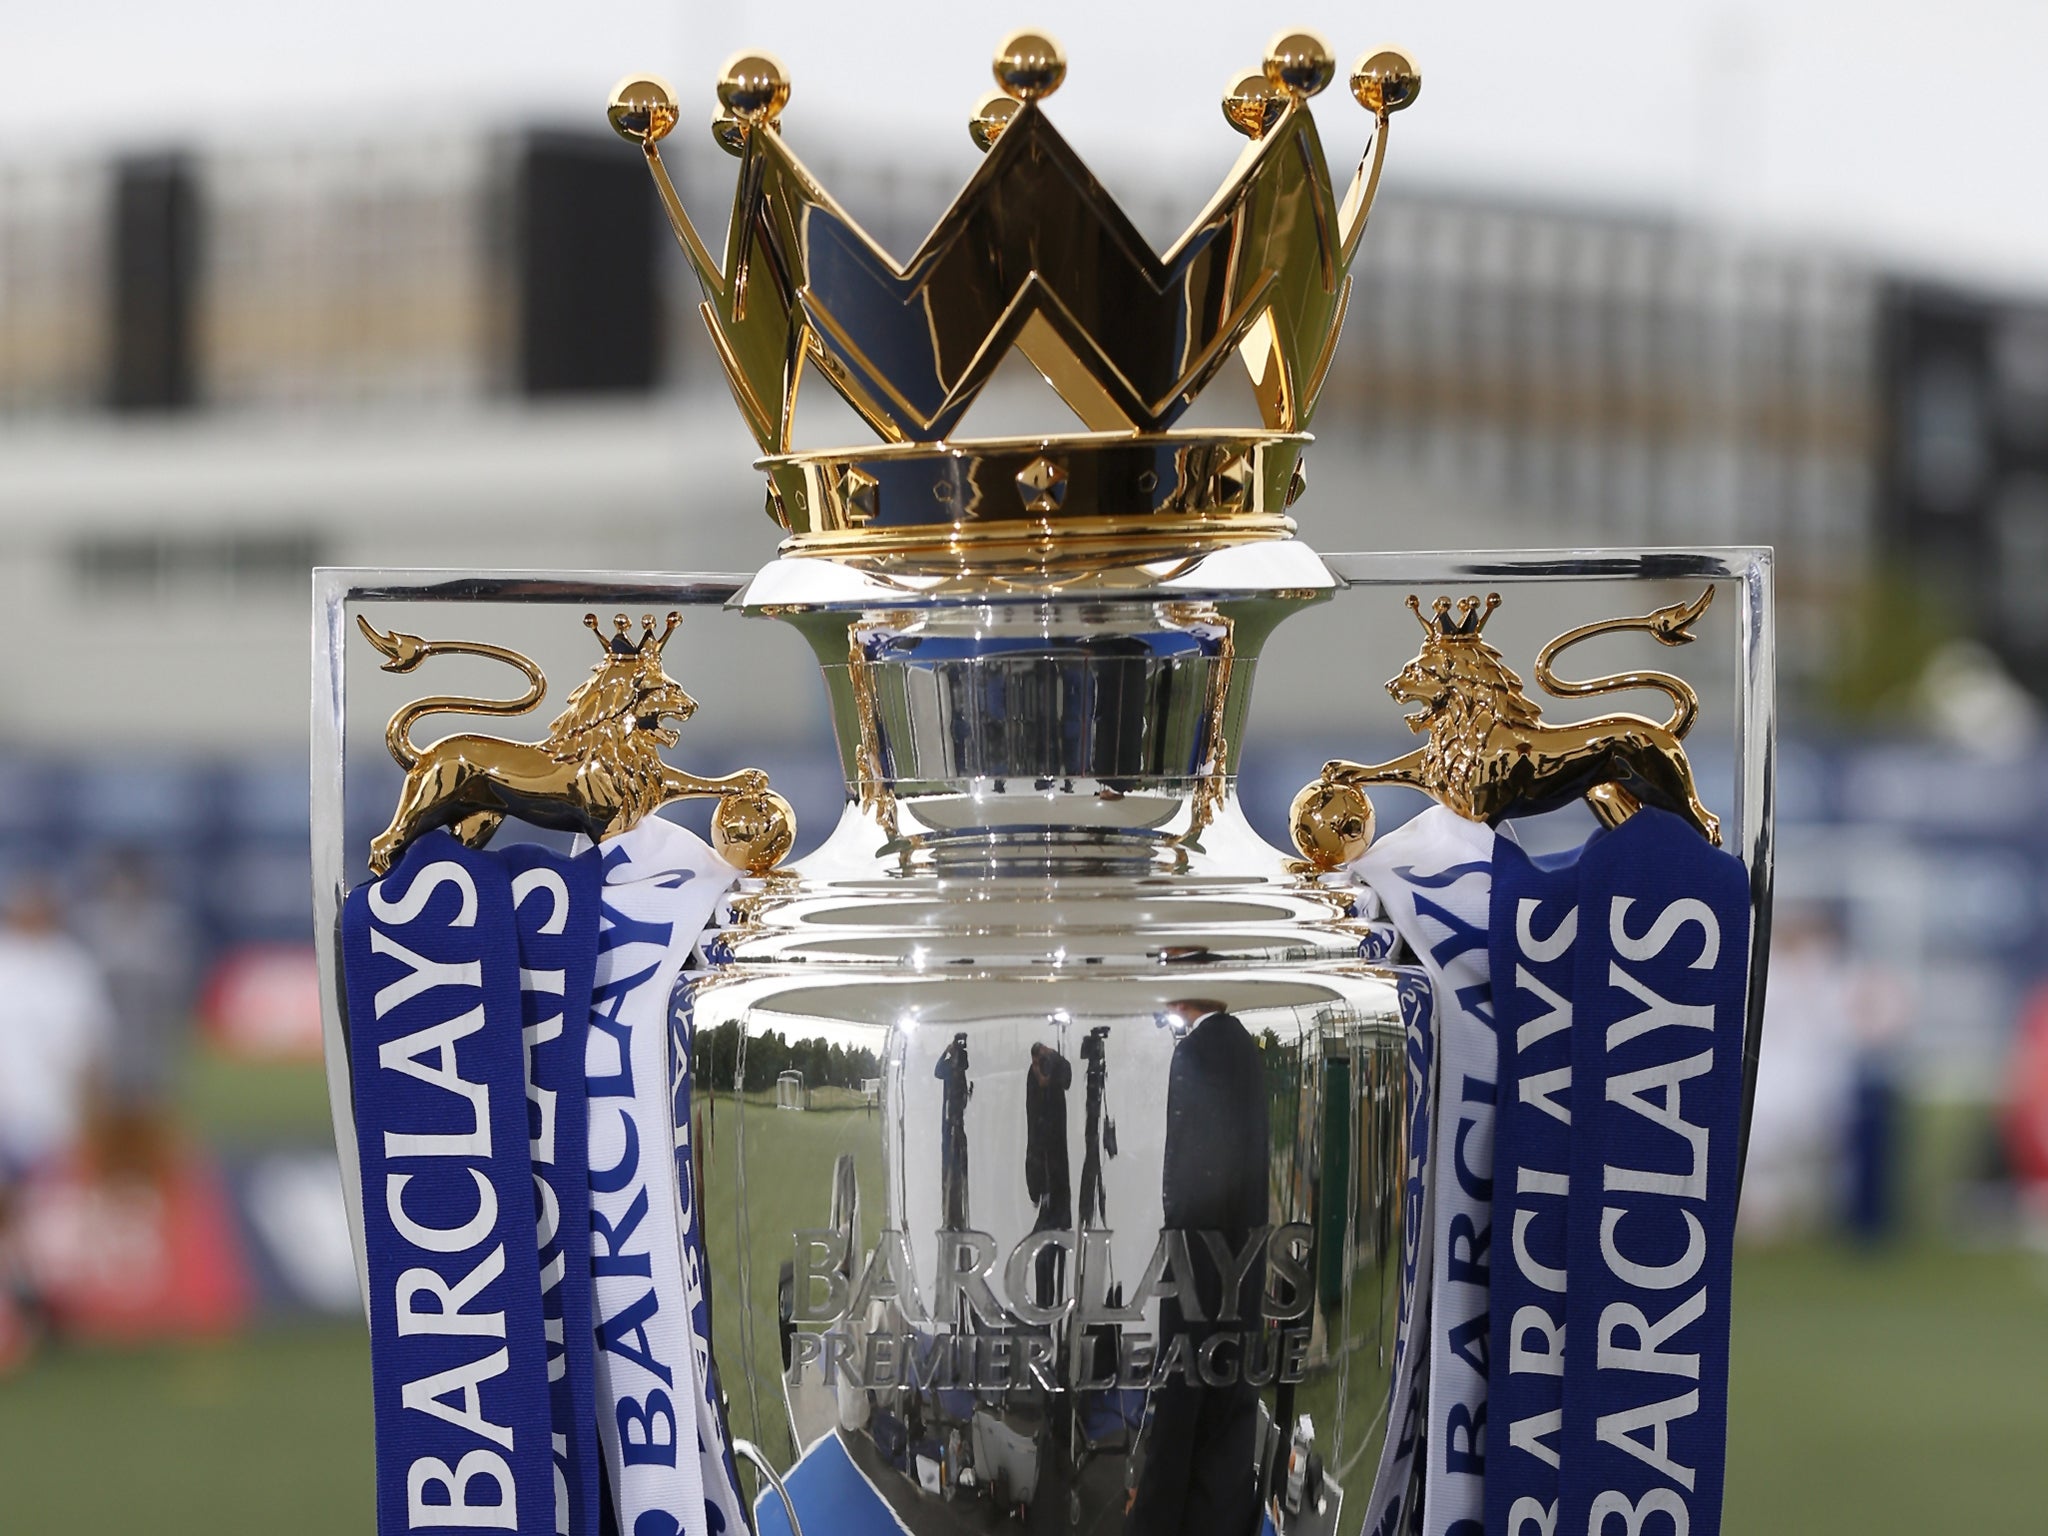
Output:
[{"xmin": 78, "ymin": 850, "xmax": 197, "ymax": 1174}]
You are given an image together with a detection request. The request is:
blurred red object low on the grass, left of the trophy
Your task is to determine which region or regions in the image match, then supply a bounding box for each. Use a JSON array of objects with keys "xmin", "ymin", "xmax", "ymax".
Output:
[{"xmin": 20, "ymin": 1153, "xmax": 252, "ymax": 1341}]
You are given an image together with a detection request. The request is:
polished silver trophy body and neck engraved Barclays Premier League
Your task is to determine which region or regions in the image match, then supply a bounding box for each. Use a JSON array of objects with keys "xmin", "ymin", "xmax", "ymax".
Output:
[{"xmin": 688, "ymin": 561, "xmax": 1415, "ymax": 1536}]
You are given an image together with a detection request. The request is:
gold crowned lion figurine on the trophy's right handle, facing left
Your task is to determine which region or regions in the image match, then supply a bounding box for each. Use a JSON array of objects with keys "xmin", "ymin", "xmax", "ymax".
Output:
[{"xmin": 1321, "ymin": 586, "xmax": 1720, "ymax": 846}]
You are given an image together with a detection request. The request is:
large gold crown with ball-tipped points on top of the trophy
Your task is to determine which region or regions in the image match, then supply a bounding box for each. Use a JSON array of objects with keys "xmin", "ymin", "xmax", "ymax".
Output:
[{"xmin": 610, "ymin": 33, "xmax": 1421, "ymax": 553}]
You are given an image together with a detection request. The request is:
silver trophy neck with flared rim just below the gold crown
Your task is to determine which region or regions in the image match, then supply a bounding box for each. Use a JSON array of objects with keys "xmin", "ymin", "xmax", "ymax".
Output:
[{"xmin": 748, "ymin": 541, "xmax": 1333, "ymax": 852}]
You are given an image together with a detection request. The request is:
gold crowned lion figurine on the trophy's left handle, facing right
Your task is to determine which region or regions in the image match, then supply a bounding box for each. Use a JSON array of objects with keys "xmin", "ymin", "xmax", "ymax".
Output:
[{"xmin": 356, "ymin": 612, "xmax": 768, "ymax": 874}]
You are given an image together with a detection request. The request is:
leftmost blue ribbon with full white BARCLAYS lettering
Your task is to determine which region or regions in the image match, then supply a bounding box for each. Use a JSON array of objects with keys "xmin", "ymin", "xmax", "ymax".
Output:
[{"xmin": 342, "ymin": 831, "xmax": 555, "ymax": 1536}]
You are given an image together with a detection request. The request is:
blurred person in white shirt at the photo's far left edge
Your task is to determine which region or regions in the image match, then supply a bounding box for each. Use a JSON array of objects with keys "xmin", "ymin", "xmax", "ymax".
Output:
[{"xmin": 0, "ymin": 879, "xmax": 113, "ymax": 1370}]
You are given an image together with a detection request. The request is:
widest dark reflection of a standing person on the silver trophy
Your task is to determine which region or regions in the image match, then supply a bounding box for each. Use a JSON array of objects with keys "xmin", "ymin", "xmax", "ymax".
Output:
[{"xmin": 1124, "ymin": 999, "xmax": 1272, "ymax": 1536}]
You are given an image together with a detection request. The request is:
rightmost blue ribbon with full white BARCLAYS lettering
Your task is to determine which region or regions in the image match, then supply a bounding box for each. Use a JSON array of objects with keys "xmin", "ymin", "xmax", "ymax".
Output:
[{"xmin": 1556, "ymin": 809, "xmax": 1749, "ymax": 1536}]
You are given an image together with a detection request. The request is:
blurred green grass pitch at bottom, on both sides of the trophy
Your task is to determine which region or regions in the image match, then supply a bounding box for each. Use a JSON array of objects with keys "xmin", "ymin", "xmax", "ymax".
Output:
[{"xmin": 0, "ymin": 1247, "xmax": 2048, "ymax": 1536}]
